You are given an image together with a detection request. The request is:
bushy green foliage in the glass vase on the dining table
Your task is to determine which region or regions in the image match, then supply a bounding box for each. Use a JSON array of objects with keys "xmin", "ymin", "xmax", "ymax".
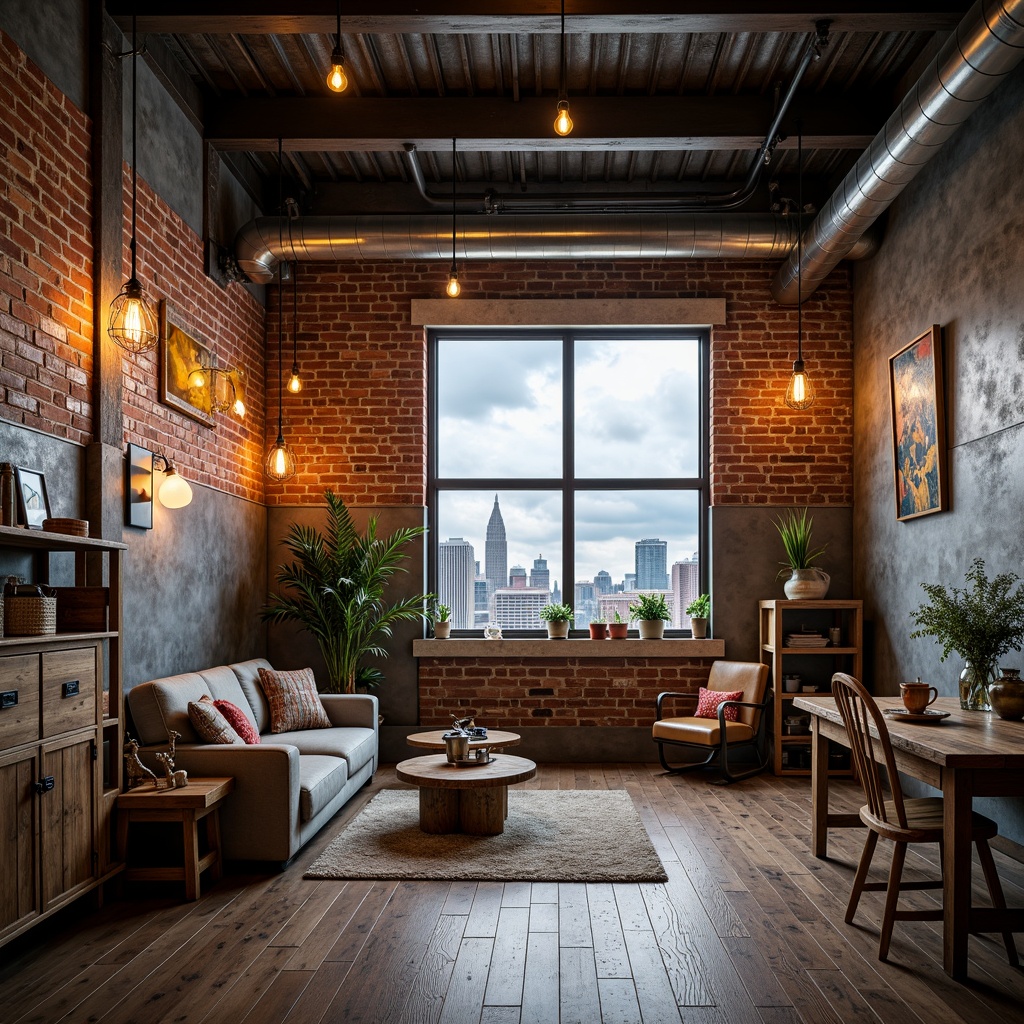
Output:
[{"xmin": 910, "ymin": 558, "xmax": 1024, "ymax": 679}]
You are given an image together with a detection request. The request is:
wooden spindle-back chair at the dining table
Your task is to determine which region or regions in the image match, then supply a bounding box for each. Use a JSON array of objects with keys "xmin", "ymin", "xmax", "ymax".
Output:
[{"xmin": 833, "ymin": 672, "xmax": 1019, "ymax": 967}]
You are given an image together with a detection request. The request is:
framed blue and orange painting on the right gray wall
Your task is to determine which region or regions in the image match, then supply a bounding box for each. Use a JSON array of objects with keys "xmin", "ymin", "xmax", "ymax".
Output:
[{"xmin": 889, "ymin": 324, "xmax": 947, "ymax": 521}]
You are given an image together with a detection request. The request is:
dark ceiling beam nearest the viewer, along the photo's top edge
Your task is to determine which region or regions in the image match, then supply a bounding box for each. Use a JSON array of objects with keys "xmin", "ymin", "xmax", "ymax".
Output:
[{"xmin": 106, "ymin": 0, "xmax": 965, "ymax": 35}]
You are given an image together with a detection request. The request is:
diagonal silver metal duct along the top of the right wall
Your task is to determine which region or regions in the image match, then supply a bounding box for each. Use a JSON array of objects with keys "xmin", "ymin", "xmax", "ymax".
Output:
[{"xmin": 772, "ymin": 0, "xmax": 1024, "ymax": 305}]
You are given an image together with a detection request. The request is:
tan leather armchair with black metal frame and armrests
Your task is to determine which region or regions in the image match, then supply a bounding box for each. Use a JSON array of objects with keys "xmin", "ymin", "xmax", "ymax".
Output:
[{"xmin": 651, "ymin": 662, "xmax": 772, "ymax": 782}]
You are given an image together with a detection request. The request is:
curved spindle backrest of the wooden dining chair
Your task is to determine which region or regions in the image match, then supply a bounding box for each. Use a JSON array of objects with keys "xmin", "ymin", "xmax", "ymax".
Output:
[{"xmin": 833, "ymin": 672, "xmax": 907, "ymax": 828}]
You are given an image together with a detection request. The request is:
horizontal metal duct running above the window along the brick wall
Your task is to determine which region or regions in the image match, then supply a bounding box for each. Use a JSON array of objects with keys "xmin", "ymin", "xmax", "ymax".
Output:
[{"xmin": 234, "ymin": 213, "xmax": 879, "ymax": 283}]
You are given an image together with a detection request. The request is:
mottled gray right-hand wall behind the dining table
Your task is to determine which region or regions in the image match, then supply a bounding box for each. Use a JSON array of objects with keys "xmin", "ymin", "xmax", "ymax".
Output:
[{"xmin": 853, "ymin": 67, "xmax": 1024, "ymax": 842}]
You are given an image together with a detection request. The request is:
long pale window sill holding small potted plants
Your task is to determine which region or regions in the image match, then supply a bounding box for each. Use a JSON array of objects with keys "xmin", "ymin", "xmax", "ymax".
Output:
[{"xmin": 413, "ymin": 638, "xmax": 725, "ymax": 660}]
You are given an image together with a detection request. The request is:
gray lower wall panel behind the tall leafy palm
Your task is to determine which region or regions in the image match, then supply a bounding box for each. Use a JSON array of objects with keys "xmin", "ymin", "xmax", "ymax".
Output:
[{"xmin": 266, "ymin": 505, "xmax": 427, "ymax": 726}]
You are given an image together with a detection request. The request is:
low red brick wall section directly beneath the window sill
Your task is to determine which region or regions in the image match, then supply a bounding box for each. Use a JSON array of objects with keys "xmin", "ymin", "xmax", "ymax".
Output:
[{"xmin": 419, "ymin": 657, "xmax": 713, "ymax": 729}]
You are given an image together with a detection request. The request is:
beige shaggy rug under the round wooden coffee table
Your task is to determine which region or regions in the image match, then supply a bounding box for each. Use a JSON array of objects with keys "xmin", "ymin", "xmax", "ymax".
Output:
[{"xmin": 305, "ymin": 790, "xmax": 668, "ymax": 882}]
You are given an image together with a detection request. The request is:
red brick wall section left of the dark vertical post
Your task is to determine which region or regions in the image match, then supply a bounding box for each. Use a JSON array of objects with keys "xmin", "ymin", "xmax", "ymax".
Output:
[{"xmin": 0, "ymin": 32, "xmax": 92, "ymax": 441}]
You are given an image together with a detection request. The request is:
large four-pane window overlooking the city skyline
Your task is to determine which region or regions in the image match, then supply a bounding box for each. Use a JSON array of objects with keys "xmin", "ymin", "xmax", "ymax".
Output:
[{"xmin": 428, "ymin": 329, "xmax": 708, "ymax": 635}]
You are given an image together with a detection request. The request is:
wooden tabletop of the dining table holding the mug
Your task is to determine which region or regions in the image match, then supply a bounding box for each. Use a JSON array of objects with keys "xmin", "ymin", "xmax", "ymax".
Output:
[{"xmin": 793, "ymin": 694, "xmax": 1024, "ymax": 768}]
